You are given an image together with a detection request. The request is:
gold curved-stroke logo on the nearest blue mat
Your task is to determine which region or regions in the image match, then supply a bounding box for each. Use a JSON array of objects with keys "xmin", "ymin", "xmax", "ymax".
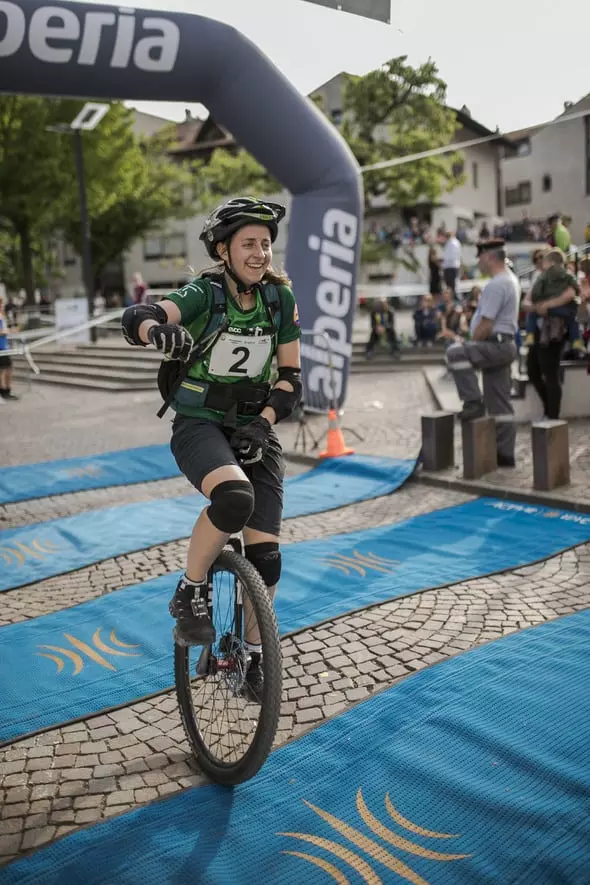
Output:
[{"xmin": 277, "ymin": 787, "xmax": 471, "ymax": 885}]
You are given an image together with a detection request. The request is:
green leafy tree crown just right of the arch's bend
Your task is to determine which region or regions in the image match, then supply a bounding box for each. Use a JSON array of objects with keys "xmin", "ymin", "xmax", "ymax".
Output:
[{"xmin": 342, "ymin": 55, "xmax": 462, "ymax": 207}]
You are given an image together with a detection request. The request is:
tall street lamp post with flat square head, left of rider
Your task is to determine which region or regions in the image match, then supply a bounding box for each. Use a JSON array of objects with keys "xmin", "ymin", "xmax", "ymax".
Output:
[{"xmin": 47, "ymin": 101, "xmax": 109, "ymax": 343}]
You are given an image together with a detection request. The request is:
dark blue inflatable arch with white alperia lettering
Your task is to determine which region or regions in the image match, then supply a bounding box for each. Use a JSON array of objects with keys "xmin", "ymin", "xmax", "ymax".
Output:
[{"xmin": 0, "ymin": 0, "xmax": 362, "ymax": 405}]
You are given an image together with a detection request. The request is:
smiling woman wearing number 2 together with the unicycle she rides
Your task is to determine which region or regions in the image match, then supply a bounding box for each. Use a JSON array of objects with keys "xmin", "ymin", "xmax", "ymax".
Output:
[{"xmin": 122, "ymin": 198, "xmax": 301, "ymax": 783}]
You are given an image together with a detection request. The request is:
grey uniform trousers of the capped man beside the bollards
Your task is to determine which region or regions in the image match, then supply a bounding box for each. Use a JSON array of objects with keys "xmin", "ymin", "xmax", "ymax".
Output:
[{"xmin": 446, "ymin": 338, "xmax": 517, "ymax": 458}]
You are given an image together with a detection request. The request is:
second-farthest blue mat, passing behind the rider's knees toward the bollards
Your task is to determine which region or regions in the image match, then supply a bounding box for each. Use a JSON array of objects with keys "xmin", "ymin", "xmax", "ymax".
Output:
[{"xmin": 0, "ymin": 455, "xmax": 416, "ymax": 591}]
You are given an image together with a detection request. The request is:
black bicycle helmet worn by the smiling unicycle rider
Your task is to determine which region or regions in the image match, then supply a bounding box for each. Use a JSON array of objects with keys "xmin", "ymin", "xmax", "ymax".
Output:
[{"xmin": 199, "ymin": 197, "xmax": 286, "ymax": 261}]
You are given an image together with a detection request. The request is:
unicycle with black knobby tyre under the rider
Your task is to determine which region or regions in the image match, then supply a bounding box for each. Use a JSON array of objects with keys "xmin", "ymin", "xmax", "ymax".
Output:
[{"xmin": 174, "ymin": 538, "xmax": 282, "ymax": 785}]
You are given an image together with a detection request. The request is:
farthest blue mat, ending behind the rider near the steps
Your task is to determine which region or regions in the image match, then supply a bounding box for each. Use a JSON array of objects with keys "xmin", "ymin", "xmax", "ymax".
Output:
[{"xmin": 0, "ymin": 445, "xmax": 180, "ymax": 504}]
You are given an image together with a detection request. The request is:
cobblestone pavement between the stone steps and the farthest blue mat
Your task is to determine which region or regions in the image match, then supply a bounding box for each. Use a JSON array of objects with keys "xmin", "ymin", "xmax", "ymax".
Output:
[{"xmin": 2, "ymin": 371, "xmax": 433, "ymax": 466}]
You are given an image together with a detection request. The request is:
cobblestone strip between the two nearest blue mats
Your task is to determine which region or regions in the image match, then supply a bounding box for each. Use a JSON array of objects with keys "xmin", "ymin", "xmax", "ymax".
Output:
[{"xmin": 0, "ymin": 545, "xmax": 590, "ymax": 863}]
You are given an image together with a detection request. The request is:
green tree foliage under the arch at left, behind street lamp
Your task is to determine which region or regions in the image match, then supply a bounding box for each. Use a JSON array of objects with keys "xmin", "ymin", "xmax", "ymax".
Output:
[{"xmin": 0, "ymin": 96, "xmax": 194, "ymax": 302}]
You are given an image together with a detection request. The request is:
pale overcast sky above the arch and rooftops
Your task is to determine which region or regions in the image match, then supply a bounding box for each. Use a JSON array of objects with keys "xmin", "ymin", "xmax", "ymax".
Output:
[{"xmin": 84, "ymin": 0, "xmax": 590, "ymax": 132}]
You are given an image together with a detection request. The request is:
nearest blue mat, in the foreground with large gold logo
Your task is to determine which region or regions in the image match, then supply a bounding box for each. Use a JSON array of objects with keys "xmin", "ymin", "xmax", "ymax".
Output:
[{"xmin": 0, "ymin": 612, "xmax": 590, "ymax": 885}]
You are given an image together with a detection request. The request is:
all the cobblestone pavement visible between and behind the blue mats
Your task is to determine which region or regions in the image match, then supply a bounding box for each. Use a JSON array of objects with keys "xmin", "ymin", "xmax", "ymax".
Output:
[{"xmin": 0, "ymin": 372, "xmax": 590, "ymax": 864}]
